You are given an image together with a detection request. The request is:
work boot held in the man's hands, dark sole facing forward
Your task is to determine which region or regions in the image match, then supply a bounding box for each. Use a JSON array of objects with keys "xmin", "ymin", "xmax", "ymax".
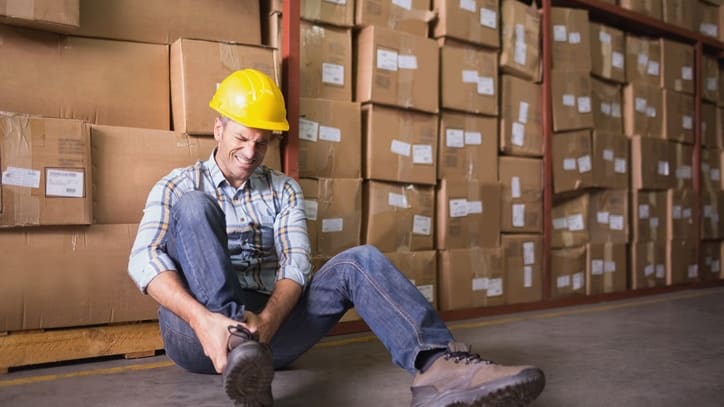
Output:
[{"xmin": 223, "ymin": 325, "xmax": 274, "ymax": 407}]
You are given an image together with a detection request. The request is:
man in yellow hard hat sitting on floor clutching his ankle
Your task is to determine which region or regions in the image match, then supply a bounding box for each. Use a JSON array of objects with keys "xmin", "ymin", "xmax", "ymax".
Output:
[{"xmin": 129, "ymin": 69, "xmax": 545, "ymax": 406}]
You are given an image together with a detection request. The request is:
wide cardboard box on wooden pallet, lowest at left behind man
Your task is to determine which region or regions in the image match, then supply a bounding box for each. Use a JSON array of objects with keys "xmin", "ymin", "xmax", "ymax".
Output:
[{"xmin": 0, "ymin": 225, "xmax": 158, "ymax": 332}]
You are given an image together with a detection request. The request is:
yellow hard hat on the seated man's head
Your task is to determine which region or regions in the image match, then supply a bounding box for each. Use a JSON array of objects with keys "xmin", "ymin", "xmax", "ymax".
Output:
[{"xmin": 209, "ymin": 69, "xmax": 289, "ymax": 131}]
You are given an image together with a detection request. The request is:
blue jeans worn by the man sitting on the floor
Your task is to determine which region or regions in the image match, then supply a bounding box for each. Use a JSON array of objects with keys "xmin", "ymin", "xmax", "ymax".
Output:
[{"xmin": 159, "ymin": 192, "xmax": 452, "ymax": 374}]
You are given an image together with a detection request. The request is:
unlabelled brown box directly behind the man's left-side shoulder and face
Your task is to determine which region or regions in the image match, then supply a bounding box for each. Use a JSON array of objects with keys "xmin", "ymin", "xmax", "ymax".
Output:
[{"xmin": 91, "ymin": 125, "xmax": 216, "ymax": 224}]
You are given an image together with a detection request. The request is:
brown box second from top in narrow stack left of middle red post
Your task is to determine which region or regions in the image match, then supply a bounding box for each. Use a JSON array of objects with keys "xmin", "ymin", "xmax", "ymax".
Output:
[{"xmin": 500, "ymin": 75, "xmax": 543, "ymax": 157}]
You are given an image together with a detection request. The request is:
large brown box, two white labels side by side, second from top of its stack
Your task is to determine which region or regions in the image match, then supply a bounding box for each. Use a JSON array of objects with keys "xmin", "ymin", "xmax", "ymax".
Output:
[{"xmin": 355, "ymin": 26, "xmax": 440, "ymax": 113}]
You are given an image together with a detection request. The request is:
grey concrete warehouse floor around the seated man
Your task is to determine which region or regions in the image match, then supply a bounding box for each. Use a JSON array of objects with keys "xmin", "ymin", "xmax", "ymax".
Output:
[{"xmin": 0, "ymin": 287, "xmax": 724, "ymax": 407}]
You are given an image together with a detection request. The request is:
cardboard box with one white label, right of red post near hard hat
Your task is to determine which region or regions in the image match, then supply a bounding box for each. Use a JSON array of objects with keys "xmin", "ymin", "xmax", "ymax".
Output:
[{"xmin": 299, "ymin": 21, "xmax": 352, "ymax": 102}]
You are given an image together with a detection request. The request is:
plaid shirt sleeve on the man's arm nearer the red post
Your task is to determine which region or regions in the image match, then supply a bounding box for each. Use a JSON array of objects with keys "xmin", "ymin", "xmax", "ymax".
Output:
[{"xmin": 274, "ymin": 177, "xmax": 312, "ymax": 287}]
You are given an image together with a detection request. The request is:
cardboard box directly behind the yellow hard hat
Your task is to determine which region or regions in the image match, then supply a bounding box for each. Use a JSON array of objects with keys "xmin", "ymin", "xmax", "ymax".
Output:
[{"xmin": 170, "ymin": 38, "xmax": 279, "ymax": 135}]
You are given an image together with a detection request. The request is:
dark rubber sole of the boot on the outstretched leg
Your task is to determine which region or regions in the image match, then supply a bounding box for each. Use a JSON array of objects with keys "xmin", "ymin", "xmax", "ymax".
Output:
[{"xmin": 425, "ymin": 369, "xmax": 545, "ymax": 407}]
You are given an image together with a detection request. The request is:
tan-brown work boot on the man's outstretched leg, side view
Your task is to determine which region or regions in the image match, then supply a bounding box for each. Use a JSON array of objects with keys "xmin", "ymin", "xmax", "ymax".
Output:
[{"xmin": 411, "ymin": 342, "xmax": 545, "ymax": 407}]
